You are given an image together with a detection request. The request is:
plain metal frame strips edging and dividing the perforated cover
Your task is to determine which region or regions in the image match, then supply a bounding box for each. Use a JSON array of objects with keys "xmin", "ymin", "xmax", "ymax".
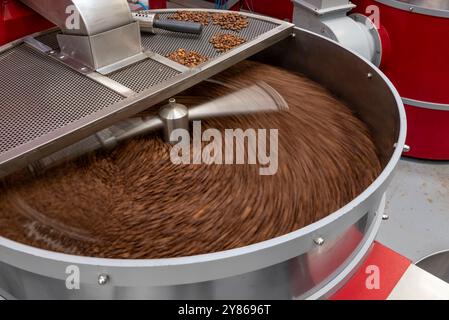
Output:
[{"xmin": 0, "ymin": 9, "xmax": 294, "ymax": 177}]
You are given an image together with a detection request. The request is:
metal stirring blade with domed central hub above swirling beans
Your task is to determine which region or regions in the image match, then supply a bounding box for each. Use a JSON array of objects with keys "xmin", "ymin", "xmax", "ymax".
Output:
[{"xmin": 28, "ymin": 82, "xmax": 288, "ymax": 173}]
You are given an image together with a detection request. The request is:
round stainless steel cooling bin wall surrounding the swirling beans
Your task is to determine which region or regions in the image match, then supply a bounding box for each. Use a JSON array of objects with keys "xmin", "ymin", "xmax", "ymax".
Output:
[{"xmin": 0, "ymin": 25, "xmax": 406, "ymax": 299}]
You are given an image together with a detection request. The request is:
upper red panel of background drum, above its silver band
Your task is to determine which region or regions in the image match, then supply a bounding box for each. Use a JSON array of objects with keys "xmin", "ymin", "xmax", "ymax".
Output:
[{"xmin": 352, "ymin": 0, "xmax": 449, "ymax": 104}]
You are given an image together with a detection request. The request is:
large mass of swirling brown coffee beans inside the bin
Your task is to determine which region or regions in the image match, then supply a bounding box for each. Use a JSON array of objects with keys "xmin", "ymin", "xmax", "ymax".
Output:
[{"xmin": 0, "ymin": 62, "xmax": 381, "ymax": 259}]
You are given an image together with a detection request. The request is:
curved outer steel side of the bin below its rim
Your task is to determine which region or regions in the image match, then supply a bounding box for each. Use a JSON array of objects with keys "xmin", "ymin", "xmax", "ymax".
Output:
[{"xmin": 0, "ymin": 208, "xmax": 380, "ymax": 299}]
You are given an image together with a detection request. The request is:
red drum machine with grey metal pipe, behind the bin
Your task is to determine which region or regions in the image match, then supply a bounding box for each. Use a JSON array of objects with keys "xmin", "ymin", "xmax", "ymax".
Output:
[{"xmin": 293, "ymin": 0, "xmax": 449, "ymax": 160}]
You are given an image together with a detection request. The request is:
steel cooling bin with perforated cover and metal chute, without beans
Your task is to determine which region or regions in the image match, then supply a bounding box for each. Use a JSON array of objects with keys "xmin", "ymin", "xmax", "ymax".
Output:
[{"xmin": 0, "ymin": 0, "xmax": 406, "ymax": 299}]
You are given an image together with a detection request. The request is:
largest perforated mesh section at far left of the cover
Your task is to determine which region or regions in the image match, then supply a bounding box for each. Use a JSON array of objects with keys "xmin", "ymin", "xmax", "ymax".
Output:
[{"xmin": 0, "ymin": 45, "xmax": 123, "ymax": 153}]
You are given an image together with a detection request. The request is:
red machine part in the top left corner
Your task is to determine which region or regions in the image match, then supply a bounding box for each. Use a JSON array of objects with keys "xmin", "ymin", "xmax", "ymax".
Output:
[{"xmin": 0, "ymin": 0, "xmax": 53, "ymax": 45}]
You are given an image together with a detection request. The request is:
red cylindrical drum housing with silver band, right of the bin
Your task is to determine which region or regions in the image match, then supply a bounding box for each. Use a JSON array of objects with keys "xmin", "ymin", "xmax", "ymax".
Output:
[{"xmin": 352, "ymin": 0, "xmax": 449, "ymax": 160}]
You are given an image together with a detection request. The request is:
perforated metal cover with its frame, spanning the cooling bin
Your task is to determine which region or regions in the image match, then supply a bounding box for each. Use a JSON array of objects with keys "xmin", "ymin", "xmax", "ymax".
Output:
[{"xmin": 0, "ymin": 10, "xmax": 294, "ymax": 178}]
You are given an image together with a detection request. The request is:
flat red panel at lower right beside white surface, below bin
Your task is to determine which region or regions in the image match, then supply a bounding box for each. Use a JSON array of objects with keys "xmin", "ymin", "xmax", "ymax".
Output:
[{"xmin": 331, "ymin": 242, "xmax": 411, "ymax": 300}]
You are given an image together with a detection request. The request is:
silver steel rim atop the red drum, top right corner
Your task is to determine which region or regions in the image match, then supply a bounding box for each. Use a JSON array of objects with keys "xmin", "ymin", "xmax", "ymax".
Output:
[{"xmin": 376, "ymin": 0, "xmax": 449, "ymax": 18}]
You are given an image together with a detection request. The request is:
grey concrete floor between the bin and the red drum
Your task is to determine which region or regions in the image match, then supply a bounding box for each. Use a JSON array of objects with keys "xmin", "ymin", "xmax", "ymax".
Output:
[{"xmin": 377, "ymin": 159, "xmax": 449, "ymax": 262}]
